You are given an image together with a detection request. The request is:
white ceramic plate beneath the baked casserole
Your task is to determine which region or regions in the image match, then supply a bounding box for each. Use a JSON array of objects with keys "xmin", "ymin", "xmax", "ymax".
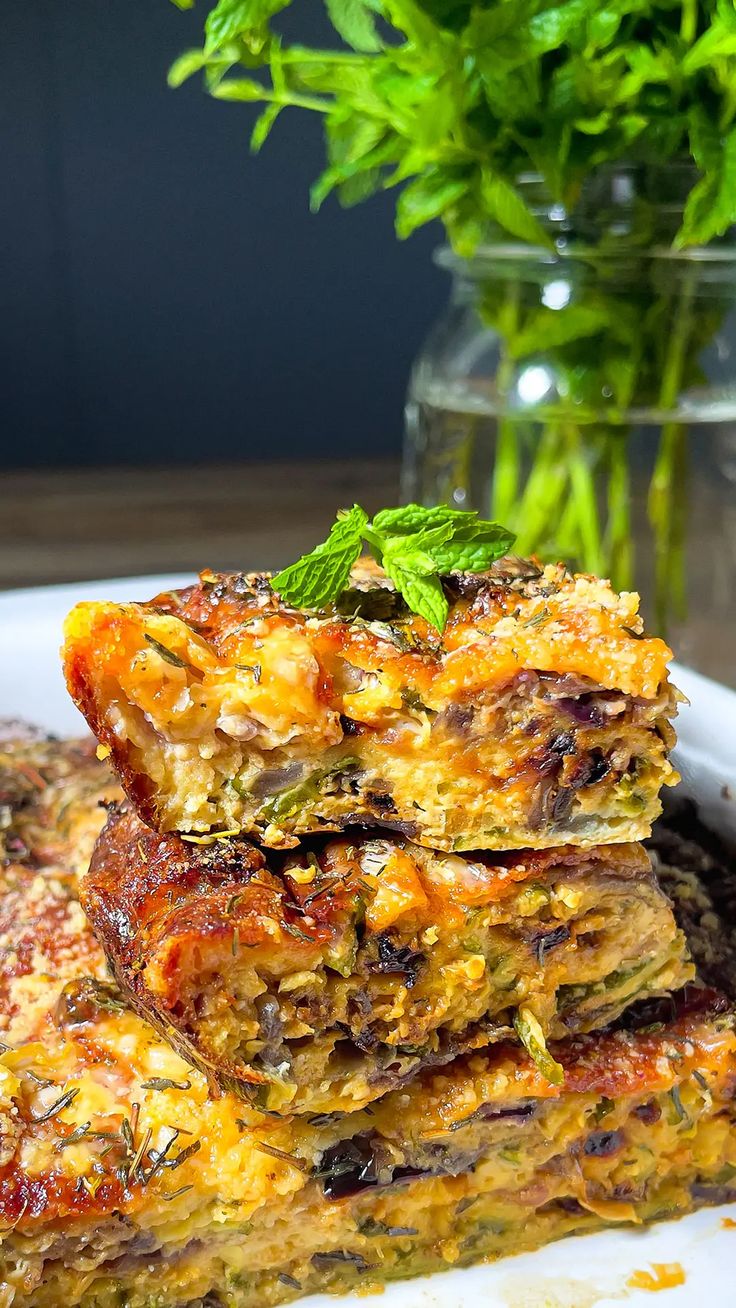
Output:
[{"xmin": 0, "ymin": 577, "xmax": 736, "ymax": 1308}]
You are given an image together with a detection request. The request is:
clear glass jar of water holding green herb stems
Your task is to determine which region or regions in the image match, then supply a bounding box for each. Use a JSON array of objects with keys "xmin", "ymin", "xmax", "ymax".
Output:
[{"xmin": 403, "ymin": 170, "xmax": 736, "ymax": 685}]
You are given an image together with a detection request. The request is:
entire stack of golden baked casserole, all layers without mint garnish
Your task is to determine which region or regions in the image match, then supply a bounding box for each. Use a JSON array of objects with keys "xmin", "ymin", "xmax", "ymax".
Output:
[{"xmin": 3, "ymin": 560, "xmax": 736, "ymax": 1308}]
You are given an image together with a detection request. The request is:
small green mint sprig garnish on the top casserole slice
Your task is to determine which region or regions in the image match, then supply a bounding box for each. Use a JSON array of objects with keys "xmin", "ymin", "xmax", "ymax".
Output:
[{"xmin": 272, "ymin": 504, "xmax": 515, "ymax": 632}]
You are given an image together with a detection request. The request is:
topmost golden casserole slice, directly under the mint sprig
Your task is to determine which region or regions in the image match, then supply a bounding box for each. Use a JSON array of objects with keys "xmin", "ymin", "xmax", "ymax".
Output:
[{"xmin": 64, "ymin": 559, "xmax": 676, "ymax": 850}]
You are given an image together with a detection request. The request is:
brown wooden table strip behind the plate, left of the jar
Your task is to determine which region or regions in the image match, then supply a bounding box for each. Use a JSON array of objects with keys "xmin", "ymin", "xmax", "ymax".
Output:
[{"xmin": 0, "ymin": 459, "xmax": 399, "ymax": 590}]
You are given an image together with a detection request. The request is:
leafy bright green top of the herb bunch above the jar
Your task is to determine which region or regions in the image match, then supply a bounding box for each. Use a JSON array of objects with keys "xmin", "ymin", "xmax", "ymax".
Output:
[{"xmin": 170, "ymin": 0, "xmax": 736, "ymax": 254}]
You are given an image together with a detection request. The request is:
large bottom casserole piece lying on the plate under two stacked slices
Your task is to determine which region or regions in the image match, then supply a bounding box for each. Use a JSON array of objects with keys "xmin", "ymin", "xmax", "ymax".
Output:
[{"xmin": 0, "ymin": 746, "xmax": 736, "ymax": 1308}]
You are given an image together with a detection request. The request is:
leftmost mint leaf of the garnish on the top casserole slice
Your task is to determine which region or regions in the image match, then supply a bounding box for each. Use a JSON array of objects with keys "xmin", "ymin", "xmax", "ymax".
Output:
[{"xmin": 272, "ymin": 504, "xmax": 369, "ymax": 608}]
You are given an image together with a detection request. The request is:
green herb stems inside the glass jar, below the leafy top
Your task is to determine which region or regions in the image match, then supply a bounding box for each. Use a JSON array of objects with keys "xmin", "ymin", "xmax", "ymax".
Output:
[{"xmin": 473, "ymin": 252, "xmax": 726, "ymax": 634}]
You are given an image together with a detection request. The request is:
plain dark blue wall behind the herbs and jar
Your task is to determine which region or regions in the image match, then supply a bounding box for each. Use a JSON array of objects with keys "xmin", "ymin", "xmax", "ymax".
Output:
[{"xmin": 0, "ymin": 0, "xmax": 447, "ymax": 467}]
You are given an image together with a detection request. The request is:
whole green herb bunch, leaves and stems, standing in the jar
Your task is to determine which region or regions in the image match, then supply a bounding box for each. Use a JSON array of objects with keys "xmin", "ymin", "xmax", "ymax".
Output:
[{"xmin": 170, "ymin": 0, "xmax": 736, "ymax": 624}]
